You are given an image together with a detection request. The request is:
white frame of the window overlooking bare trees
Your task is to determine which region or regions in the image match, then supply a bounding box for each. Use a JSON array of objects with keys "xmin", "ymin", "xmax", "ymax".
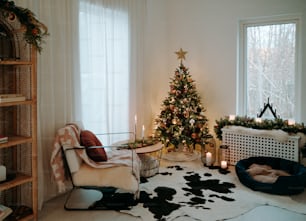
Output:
[{"xmin": 236, "ymin": 15, "xmax": 302, "ymax": 121}]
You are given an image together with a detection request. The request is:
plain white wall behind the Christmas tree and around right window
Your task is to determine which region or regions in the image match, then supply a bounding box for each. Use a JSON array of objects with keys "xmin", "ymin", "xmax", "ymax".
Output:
[{"xmin": 144, "ymin": 0, "xmax": 306, "ymax": 134}]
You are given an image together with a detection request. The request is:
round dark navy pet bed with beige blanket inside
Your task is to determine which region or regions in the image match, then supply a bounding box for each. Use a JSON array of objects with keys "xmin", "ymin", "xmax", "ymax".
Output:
[{"xmin": 235, "ymin": 157, "xmax": 306, "ymax": 195}]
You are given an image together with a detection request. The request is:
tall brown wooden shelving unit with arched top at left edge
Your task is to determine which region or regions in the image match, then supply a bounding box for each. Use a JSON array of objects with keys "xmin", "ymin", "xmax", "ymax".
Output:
[{"xmin": 0, "ymin": 11, "xmax": 38, "ymax": 220}]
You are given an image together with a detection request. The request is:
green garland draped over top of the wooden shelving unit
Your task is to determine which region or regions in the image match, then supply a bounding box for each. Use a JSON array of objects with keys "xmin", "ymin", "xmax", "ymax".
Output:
[{"xmin": 0, "ymin": 0, "xmax": 49, "ymax": 52}]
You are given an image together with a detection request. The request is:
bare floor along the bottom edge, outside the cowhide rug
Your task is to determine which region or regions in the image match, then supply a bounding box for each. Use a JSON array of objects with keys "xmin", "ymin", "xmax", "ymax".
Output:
[{"xmin": 39, "ymin": 192, "xmax": 306, "ymax": 221}]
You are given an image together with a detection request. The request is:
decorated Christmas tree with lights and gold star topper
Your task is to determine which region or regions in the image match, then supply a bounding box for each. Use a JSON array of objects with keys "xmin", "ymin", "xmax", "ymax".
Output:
[{"xmin": 155, "ymin": 49, "xmax": 212, "ymax": 147}]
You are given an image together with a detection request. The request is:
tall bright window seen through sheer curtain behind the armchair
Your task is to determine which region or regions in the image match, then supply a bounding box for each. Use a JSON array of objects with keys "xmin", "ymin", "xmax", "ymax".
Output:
[{"xmin": 78, "ymin": 1, "xmax": 130, "ymax": 145}]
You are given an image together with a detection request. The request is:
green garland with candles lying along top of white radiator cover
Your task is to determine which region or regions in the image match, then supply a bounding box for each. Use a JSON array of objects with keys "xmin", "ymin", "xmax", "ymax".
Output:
[{"xmin": 214, "ymin": 116, "xmax": 306, "ymax": 140}]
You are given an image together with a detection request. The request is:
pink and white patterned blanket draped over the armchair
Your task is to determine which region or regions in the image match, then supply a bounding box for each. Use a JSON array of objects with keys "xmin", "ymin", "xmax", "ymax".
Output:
[{"xmin": 50, "ymin": 124, "xmax": 140, "ymax": 193}]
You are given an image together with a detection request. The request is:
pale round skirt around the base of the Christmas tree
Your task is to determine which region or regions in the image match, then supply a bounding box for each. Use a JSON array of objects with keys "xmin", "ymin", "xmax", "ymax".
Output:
[{"xmin": 162, "ymin": 151, "xmax": 200, "ymax": 162}]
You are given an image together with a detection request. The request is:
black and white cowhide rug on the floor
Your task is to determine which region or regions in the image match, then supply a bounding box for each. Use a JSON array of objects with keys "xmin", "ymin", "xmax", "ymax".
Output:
[{"xmin": 121, "ymin": 160, "xmax": 306, "ymax": 221}]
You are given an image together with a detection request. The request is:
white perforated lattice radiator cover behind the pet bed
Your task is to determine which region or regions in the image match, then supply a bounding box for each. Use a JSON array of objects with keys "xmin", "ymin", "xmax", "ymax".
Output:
[{"xmin": 222, "ymin": 127, "xmax": 300, "ymax": 165}]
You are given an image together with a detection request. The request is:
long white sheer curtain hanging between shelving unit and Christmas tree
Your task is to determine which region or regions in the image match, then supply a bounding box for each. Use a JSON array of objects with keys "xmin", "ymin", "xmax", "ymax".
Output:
[{"xmin": 15, "ymin": 0, "xmax": 146, "ymax": 207}]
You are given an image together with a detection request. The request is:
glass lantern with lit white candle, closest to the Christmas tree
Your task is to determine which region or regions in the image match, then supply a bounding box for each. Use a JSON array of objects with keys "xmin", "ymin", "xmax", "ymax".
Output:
[{"xmin": 201, "ymin": 138, "xmax": 216, "ymax": 167}]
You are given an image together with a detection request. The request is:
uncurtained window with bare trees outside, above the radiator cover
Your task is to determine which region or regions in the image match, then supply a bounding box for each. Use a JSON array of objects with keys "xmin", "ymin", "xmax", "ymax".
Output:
[{"xmin": 238, "ymin": 19, "xmax": 299, "ymax": 119}]
